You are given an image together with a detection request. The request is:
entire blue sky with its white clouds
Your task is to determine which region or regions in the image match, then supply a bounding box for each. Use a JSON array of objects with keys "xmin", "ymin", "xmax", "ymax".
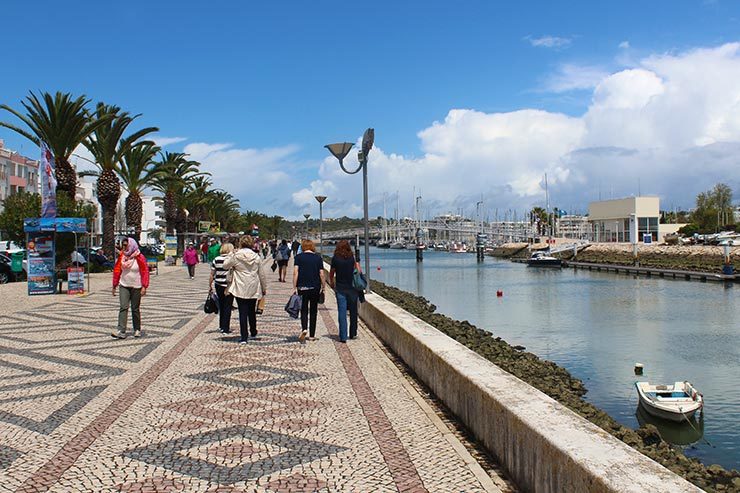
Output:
[{"xmin": 0, "ymin": 0, "xmax": 740, "ymax": 218}]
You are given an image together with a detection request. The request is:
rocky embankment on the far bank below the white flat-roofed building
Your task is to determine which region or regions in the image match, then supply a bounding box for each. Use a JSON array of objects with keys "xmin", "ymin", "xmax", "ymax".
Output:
[{"xmin": 562, "ymin": 243, "xmax": 740, "ymax": 274}]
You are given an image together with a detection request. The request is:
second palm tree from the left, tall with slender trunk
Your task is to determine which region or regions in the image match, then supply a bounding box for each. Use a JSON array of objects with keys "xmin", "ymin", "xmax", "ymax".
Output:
[{"xmin": 83, "ymin": 103, "xmax": 159, "ymax": 257}]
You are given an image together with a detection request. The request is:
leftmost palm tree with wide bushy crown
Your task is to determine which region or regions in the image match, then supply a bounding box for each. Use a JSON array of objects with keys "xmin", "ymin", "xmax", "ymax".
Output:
[{"xmin": 0, "ymin": 92, "xmax": 109, "ymax": 200}]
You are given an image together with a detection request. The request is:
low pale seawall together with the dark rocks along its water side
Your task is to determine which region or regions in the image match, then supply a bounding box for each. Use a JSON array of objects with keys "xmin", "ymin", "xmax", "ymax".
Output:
[{"xmin": 361, "ymin": 281, "xmax": 740, "ymax": 491}]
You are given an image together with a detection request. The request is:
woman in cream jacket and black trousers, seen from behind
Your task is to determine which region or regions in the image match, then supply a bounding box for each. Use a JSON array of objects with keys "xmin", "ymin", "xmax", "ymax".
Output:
[{"xmin": 224, "ymin": 236, "xmax": 267, "ymax": 344}]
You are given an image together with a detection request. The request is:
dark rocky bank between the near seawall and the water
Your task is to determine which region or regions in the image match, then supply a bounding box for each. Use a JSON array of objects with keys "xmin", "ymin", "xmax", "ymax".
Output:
[{"xmin": 373, "ymin": 281, "xmax": 740, "ymax": 492}]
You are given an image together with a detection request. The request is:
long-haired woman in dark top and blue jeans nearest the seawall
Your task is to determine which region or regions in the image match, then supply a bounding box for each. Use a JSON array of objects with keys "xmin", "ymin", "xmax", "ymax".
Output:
[{"xmin": 329, "ymin": 240, "xmax": 362, "ymax": 342}]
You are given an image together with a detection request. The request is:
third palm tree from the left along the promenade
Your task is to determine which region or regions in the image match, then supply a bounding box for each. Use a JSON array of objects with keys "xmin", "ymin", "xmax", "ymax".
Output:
[{"xmin": 118, "ymin": 142, "xmax": 160, "ymax": 240}]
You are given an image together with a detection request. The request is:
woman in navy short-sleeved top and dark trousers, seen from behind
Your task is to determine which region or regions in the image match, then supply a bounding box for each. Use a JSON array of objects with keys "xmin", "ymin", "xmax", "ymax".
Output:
[{"xmin": 293, "ymin": 240, "xmax": 325, "ymax": 342}]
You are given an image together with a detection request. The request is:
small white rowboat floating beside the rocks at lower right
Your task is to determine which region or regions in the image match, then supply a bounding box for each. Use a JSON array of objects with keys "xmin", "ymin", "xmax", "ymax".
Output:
[{"xmin": 635, "ymin": 382, "xmax": 704, "ymax": 422}]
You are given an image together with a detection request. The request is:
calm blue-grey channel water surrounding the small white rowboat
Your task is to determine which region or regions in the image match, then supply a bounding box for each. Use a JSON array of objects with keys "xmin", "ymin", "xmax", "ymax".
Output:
[{"xmin": 371, "ymin": 249, "xmax": 740, "ymax": 468}]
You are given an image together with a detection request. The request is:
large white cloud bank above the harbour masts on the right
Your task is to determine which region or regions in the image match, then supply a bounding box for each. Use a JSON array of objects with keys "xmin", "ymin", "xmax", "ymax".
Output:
[{"xmin": 291, "ymin": 43, "xmax": 740, "ymax": 216}]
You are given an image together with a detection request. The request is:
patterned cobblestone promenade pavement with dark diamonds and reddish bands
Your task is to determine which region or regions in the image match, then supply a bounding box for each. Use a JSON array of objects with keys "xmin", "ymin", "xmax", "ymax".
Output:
[{"xmin": 0, "ymin": 266, "xmax": 508, "ymax": 492}]
